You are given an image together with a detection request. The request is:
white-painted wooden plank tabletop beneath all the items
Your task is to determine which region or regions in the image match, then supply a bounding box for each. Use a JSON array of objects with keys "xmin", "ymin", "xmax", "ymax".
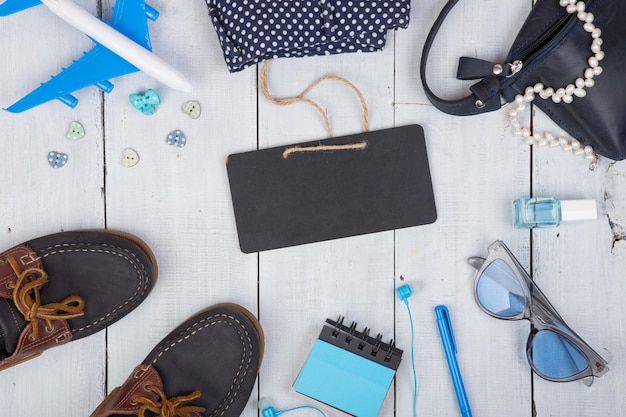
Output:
[{"xmin": 0, "ymin": 0, "xmax": 626, "ymax": 417}]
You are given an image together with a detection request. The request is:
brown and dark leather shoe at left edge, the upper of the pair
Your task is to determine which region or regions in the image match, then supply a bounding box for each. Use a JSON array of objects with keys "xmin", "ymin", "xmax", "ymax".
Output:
[{"xmin": 0, "ymin": 230, "xmax": 157, "ymax": 370}]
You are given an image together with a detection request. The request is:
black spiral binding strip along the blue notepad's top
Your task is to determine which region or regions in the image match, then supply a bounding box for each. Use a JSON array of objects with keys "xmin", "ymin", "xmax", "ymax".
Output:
[{"xmin": 319, "ymin": 316, "xmax": 403, "ymax": 370}]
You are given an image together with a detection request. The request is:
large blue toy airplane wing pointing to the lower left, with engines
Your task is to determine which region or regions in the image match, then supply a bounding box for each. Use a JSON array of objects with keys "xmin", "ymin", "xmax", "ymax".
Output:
[{"xmin": 5, "ymin": 44, "xmax": 139, "ymax": 113}]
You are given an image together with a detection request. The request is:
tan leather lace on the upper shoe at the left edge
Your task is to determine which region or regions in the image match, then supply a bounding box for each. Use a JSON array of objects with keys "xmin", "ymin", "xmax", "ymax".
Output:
[{"xmin": 7, "ymin": 257, "xmax": 85, "ymax": 340}]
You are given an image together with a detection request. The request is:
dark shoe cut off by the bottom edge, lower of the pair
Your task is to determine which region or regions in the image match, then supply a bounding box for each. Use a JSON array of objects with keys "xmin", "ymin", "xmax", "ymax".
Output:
[{"xmin": 91, "ymin": 304, "xmax": 264, "ymax": 417}]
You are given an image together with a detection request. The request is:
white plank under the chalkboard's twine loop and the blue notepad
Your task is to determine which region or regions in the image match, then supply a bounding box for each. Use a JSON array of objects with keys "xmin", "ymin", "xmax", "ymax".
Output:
[{"xmin": 259, "ymin": 38, "xmax": 394, "ymax": 416}]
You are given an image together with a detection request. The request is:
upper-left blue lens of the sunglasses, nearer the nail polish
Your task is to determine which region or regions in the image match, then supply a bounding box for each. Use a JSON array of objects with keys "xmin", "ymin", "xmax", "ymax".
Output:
[{"xmin": 476, "ymin": 259, "xmax": 526, "ymax": 317}]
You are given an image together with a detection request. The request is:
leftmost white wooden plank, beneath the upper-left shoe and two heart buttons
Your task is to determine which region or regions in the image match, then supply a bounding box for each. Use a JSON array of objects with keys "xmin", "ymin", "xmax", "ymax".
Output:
[{"xmin": 0, "ymin": 2, "xmax": 106, "ymax": 416}]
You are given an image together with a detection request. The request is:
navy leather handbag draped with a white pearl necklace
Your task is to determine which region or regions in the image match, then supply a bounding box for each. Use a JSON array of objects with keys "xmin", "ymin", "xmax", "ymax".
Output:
[{"xmin": 420, "ymin": 0, "xmax": 626, "ymax": 165}]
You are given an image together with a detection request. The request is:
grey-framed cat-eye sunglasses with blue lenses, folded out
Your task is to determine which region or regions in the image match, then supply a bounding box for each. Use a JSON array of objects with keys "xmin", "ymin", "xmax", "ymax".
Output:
[{"xmin": 467, "ymin": 240, "xmax": 609, "ymax": 386}]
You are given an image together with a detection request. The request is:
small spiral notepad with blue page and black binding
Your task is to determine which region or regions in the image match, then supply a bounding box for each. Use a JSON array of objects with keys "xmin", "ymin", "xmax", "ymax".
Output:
[{"xmin": 293, "ymin": 317, "xmax": 403, "ymax": 417}]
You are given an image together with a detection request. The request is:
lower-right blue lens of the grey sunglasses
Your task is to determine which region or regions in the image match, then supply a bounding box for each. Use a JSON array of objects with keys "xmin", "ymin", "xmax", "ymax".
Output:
[{"xmin": 530, "ymin": 330, "xmax": 589, "ymax": 379}]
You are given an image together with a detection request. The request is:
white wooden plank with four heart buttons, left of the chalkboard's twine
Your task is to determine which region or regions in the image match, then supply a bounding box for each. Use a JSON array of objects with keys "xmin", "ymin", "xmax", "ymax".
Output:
[{"xmin": 100, "ymin": 2, "xmax": 258, "ymax": 416}]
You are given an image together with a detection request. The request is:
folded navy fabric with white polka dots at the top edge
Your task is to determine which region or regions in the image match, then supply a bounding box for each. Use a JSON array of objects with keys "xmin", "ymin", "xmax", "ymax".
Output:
[{"xmin": 206, "ymin": 0, "xmax": 411, "ymax": 72}]
